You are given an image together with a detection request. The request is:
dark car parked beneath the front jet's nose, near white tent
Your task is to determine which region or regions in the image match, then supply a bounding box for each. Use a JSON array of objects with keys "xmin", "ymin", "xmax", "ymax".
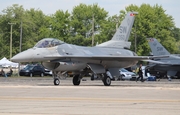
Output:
[{"xmin": 19, "ymin": 65, "xmax": 45, "ymax": 77}]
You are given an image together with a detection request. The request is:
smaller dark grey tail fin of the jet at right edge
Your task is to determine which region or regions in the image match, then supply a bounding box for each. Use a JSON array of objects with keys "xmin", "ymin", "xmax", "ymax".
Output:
[{"xmin": 147, "ymin": 38, "xmax": 170, "ymax": 56}]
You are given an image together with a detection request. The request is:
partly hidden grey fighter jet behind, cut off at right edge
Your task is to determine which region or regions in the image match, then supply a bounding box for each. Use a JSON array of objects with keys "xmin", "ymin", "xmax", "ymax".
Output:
[{"xmin": 147, "ymin": 38, "xmax": 180, "ymax": 77}]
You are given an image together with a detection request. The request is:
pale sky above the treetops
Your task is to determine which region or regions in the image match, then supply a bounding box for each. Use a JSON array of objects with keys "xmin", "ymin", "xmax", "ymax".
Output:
[{"xmin": 0, "ymin": 0, "xmax": 180, "ymax": 28}]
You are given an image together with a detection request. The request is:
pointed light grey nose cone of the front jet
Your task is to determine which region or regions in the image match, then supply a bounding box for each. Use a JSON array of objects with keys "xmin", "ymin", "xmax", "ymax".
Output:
[{"xmin": 11, "ymin": 50, "xmax": 33, "ymax": 62}]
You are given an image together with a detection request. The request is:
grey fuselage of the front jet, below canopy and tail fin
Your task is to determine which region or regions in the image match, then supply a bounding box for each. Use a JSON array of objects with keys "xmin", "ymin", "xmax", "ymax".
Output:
[{"xmin": 12, "ymin": 43, "xmax": 137, "ymax": 71}]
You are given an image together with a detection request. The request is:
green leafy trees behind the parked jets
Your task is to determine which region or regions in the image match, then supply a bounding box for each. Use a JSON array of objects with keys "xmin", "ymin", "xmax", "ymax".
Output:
[{"xmin": 0, "ymin": 4, "xmax": 180, "ymax": 58}]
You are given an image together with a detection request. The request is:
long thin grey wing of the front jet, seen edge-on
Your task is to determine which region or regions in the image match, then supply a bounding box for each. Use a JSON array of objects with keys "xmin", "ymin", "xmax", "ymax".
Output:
[{"xmin": 44, "ymin": 55, "xmax": 168, "ymax": 61}]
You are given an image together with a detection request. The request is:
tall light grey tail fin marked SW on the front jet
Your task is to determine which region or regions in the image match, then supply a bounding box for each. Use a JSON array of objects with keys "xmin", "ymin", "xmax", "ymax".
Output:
[{"xmin": 97, "ymin": 12, "xmax": 138, "ymax": 48}]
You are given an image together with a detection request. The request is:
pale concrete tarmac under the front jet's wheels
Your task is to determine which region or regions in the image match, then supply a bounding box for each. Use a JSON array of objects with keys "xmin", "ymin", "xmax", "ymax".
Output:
[{"xmin": 0, "ymin": 77, "xmax": 180, "ymax": 115}]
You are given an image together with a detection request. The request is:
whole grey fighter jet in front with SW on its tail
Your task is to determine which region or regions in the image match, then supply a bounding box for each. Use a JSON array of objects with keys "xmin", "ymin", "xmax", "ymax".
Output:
[{"xmin": 11, "ymin": 12, "xmax": 160, "ymax": 86}]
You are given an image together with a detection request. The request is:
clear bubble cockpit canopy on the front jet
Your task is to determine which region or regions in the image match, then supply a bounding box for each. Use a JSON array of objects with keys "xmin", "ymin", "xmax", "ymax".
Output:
[{"xmin": 34, "ymin": 38, "xmax": 64, "ymax": 48}]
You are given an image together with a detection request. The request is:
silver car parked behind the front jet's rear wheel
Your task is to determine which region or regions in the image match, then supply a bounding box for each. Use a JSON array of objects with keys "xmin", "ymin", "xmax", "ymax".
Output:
[{"xmin": 119, "ymin": 68, "xmax": 138, "ymax": 80}]
